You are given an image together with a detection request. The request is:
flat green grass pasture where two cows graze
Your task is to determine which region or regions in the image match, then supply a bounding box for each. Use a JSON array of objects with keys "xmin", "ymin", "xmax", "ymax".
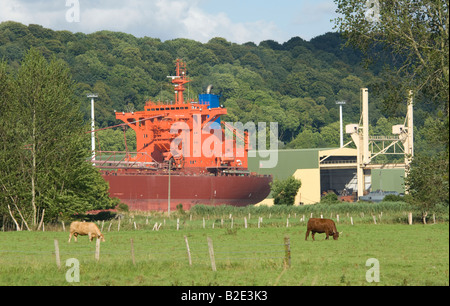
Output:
[{"xmin": 0, "ymin": 207, "xmax": 449, "ymax": 286}]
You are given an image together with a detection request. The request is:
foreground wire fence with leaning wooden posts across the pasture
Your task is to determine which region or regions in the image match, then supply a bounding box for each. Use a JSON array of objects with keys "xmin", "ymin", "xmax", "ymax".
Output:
[{"xmin": 0, "ymin": 236, "xmax": 290, "ymax": 270}]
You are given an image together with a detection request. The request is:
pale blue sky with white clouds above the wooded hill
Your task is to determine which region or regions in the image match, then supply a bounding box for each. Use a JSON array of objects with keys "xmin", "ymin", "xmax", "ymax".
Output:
[{"xmin": 0, "ymin": 0, "xmax": 336, "ymax": 44}]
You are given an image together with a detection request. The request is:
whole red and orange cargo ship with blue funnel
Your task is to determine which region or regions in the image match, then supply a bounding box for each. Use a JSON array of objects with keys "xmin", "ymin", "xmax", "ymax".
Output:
[{"xmin": 93, "ymin": 60, "xmax": 272, "ymax": 211}]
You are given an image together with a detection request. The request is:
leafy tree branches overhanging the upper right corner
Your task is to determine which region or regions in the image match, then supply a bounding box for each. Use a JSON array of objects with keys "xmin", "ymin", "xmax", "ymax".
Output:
[{"xmin": 335, "ymin": 0, "xmax": 449, "ymax": 109}]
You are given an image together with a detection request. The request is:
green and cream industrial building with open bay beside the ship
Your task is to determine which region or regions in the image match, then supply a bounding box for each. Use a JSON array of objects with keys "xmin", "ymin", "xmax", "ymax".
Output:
[{"xmin": 248, "ymin": 148, "xmax": 405, "ymax": 205}]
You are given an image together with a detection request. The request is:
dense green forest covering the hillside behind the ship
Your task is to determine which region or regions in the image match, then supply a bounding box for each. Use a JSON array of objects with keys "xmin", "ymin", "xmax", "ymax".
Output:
[{"xmin": 0, "ymin": 21, "xmax": 437, "ymax": 155}]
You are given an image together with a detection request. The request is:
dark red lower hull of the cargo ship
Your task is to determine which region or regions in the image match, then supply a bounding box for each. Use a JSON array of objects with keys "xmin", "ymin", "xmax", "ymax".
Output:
[{"xmin": 103, "ymin": 173, "xmax": 272, "ymax": 211}]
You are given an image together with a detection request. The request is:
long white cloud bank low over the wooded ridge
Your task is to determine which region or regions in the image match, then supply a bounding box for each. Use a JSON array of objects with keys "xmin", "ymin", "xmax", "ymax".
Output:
[{"xmin": 0, "ymin": 0, "xmax": 280, "ymax": 43}]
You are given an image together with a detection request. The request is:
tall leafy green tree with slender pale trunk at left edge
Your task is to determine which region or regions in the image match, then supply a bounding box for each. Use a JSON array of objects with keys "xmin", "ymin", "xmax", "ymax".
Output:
[{"xmin": 0, "ymin": 48, "xmax": 113, "ymax": 230}]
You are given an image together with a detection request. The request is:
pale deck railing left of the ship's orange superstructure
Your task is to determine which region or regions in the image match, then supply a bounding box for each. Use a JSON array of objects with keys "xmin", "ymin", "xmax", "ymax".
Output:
[{"xmin": 91, "ymin": 151, "xmax": 161, "ymax": 170}]
